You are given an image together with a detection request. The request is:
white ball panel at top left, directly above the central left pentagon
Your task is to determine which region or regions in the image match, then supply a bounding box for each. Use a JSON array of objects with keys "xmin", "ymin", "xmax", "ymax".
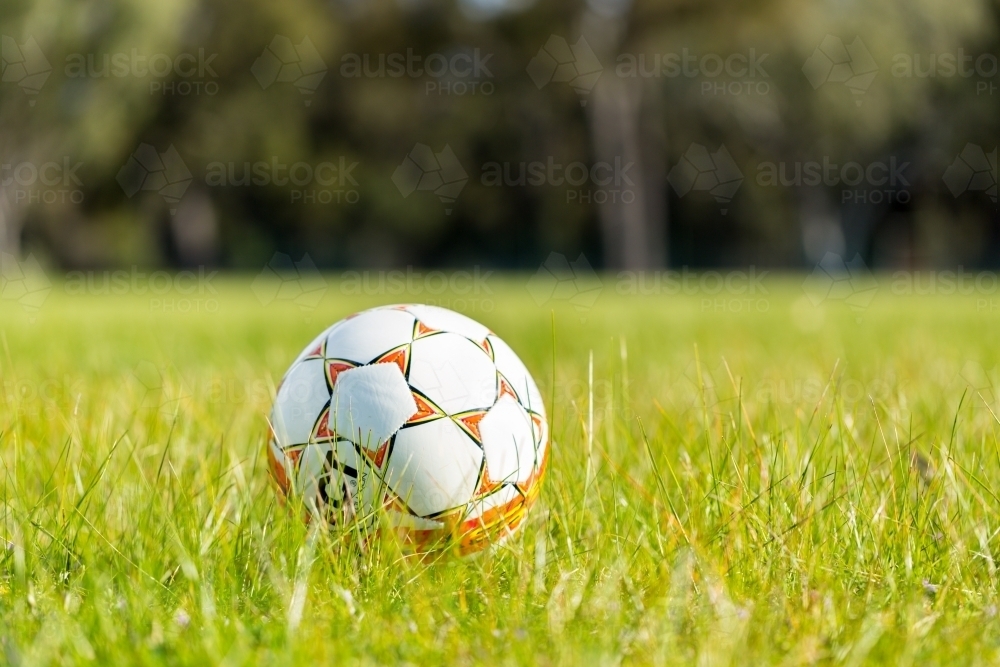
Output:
[{"xmin": 326, "ymin": 308, "xmax": 414, "ymax": 364}]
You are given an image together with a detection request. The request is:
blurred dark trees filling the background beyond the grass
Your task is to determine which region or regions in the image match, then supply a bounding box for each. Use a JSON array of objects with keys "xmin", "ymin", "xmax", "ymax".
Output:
[{"xmin": 0, "ymin": 0, "xmax": 1000, "ymax": 270}]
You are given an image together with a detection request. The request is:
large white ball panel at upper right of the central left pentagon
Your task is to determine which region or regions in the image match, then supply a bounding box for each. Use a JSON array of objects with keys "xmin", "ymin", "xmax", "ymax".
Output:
[{"xmin": 410, "ymin": 333, "xmax": 497, "ymax": 415}]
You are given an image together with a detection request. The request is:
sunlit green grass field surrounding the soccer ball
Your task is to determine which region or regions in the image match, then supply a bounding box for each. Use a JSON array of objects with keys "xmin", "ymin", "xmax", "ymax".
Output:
[{"xmin": 0, "ymin": 276, "xmax": 1000, "ymax": 665}]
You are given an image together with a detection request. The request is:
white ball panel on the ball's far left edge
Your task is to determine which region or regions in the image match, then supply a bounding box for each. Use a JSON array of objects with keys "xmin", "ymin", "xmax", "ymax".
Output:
[{"xmin": 271, "ymin": 359, "xmax": 330, "ymax": 448}]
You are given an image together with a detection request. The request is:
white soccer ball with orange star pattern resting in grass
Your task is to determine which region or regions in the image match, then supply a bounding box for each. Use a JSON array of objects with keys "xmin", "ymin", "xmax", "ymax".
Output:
[{"xmin": 267, "ymin": 305, "xmax": 548, "ymax": 553}]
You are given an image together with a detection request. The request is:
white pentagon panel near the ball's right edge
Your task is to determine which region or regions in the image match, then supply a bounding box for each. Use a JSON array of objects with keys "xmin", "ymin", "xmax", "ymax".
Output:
[{"xmin": 479, "ymin": 396, "xmax": 535, "ymax": 483}]
